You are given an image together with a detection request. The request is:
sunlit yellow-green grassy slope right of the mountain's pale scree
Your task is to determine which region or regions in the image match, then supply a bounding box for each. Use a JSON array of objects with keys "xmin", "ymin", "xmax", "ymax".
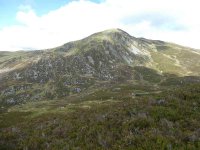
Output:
[{"xmin": 150, "ymin": 43, "xmax": 200, "ymax": 76}]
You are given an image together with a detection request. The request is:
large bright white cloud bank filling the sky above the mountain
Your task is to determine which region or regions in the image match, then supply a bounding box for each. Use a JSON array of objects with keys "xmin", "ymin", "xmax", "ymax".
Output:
[{"xmin": 0, "ymin": 0, "xmax": 200, "ymax": 51}]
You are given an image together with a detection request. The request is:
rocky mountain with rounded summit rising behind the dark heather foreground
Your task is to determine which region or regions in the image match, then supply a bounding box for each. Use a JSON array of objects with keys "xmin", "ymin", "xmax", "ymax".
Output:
[{"xmin": 0, "ymin": 29, "xmax": 200, "ymax": 105}]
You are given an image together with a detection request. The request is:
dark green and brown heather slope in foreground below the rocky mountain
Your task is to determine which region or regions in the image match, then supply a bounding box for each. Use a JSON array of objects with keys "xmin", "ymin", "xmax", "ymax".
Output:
[{"xmin": 0, "ymin": 84, "xmax": 200, "ymax": 149}]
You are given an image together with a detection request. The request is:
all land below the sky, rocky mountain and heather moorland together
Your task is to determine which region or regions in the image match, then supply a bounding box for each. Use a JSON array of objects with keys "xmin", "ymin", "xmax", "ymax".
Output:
[{"xmin": 0, "ymin": 29, "xmax": 200, "ymax": 150}]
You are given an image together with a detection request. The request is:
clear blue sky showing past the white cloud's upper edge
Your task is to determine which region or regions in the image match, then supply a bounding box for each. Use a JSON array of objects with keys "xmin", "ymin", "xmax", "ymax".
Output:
[{"xmin": 0, "ymin": 0, "xmax": 103, "ymax": 28}]
